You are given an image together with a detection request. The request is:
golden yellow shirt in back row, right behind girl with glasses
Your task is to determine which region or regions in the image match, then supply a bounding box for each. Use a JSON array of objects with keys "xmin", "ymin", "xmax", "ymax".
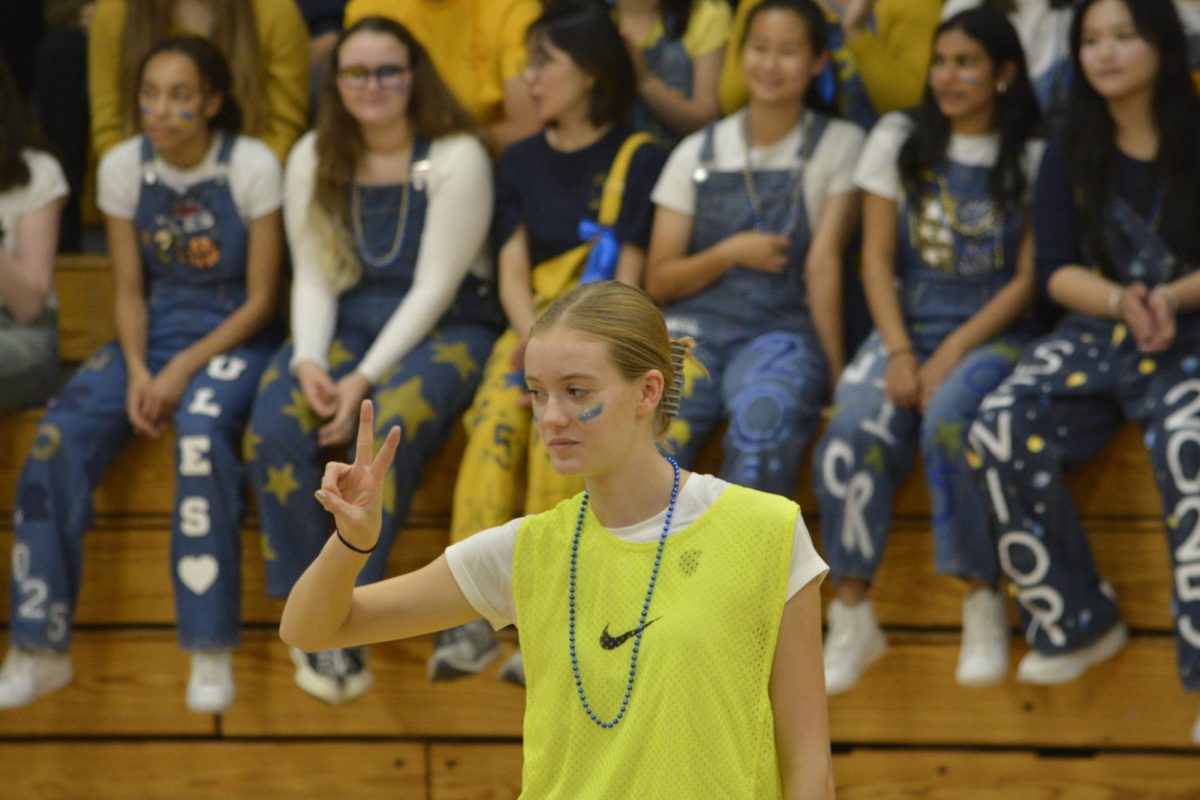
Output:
[{"xmin": 346, "ymin": 0, "xmax": 541, "ymax": 125}]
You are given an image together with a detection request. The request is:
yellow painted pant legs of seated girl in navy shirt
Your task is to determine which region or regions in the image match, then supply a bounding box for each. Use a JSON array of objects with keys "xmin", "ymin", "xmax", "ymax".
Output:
[{"xmin": 450, "ymin": 329, "xmax": 583, "ymax": 543}]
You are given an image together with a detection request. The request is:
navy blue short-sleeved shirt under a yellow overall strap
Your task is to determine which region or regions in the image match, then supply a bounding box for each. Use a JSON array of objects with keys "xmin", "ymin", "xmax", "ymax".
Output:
[{"xmin": 493, "ymin": 125, "xmax": 666, "ymax": 266}]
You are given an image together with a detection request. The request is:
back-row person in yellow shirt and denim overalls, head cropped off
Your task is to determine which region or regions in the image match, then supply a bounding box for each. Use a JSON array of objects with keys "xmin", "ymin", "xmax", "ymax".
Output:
[{"xmin": 605, "ymin": 0, "xmax": 733, "ymax": 148}]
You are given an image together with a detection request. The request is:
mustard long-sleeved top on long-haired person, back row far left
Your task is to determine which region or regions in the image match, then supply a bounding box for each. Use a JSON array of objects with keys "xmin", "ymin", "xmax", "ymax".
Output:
[{"xmin": 88, "ymin": 0, "xmax": 308, "ymax": 164}]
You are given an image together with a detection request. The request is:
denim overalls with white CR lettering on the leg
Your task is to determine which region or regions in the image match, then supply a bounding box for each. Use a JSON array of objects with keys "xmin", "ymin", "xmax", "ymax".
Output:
[{"xmin": 814, "ymin": 155, "xmax": 1027, "ymax": 583}]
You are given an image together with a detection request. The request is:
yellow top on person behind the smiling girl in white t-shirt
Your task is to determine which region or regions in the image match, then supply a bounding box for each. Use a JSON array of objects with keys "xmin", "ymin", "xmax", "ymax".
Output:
[{"xmin": 718, "ymin": 0, "xmax": 942, "ymax": 116}]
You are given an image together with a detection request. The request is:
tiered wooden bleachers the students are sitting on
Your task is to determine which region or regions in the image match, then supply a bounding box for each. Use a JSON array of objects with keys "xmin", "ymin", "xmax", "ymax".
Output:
[{"xmin": 0, "ymin": 259, "xmax": 1200, "ymax": 800}]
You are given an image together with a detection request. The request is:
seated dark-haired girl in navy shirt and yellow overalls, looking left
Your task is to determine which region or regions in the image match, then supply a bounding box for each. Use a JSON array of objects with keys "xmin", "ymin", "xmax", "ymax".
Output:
[{"xmin": 430, "ymin": 2, "xmax": 664, "ymax": 682}]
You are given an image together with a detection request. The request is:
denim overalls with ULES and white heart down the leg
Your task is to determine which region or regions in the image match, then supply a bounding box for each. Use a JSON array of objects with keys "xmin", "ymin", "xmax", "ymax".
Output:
[{"xmin": 12, "ymin": 137, "xmax": 278, "ymax": 650}]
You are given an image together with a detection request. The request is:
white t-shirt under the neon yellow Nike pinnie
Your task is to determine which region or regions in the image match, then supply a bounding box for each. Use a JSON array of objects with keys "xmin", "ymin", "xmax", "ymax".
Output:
[{"xmin": 446, "ymin": 473, "xmax": 829, "ymax": 630}]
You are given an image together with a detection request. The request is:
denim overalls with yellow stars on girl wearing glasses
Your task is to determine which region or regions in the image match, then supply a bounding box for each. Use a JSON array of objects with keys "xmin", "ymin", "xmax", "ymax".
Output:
[{"xmin": 245, "ymin": 138, "xmax": 499, "ymax": 597}]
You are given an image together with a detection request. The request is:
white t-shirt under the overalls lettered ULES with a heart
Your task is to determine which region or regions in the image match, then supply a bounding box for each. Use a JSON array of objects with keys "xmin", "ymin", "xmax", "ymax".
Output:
[{"xmin": 96, "ymin": 134, "xmax": 283, "ymax": 223}]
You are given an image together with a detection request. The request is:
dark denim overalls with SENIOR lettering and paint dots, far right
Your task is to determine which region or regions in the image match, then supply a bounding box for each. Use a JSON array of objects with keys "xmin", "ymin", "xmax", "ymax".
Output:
[{"xmin": 971, "ymin": 198, "xmax": 1200, "ymax": 691}]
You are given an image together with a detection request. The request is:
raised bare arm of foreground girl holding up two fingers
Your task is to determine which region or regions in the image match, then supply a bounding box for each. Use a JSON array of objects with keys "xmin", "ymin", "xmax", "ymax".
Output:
[{"xmin": 280, "ymin": 401, "xmax": 479, "ymax": 652}]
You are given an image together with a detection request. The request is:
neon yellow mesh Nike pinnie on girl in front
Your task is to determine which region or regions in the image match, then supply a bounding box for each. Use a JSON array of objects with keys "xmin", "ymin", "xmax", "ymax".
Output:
[{"xmin": 512, "ymin": 486, "xmax": 799, "ymax": 800}]
